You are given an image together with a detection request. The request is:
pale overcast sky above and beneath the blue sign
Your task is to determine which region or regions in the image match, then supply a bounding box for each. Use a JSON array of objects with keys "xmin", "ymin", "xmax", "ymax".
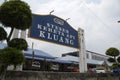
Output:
[{"xmin": 0, "ymin": 0, "xmax": 120, "ymax": 57}]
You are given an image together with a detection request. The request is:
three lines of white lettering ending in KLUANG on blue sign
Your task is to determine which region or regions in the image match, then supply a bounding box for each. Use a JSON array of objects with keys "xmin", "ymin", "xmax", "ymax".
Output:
[{"xmin": 37, "ymin": 23, "xmax": 75, "ymax": 46}]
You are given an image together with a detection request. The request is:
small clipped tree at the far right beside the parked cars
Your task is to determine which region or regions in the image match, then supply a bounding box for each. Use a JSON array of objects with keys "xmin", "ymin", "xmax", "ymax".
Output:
[{"xmin": 105, "ymin": 47, "xmax": 120, "ymax": 69}]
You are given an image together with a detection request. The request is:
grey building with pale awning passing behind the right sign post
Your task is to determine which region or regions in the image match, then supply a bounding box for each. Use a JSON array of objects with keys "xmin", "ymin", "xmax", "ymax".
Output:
[{"xmin": 61, "ymin": 50, "xmax": 112, "ymax": 70}]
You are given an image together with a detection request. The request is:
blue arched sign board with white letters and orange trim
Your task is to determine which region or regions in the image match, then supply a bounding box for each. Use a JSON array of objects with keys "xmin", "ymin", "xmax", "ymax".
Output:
[{"xmin": 29, "ymin": 14, "xmax": 78, "ymax": 48}]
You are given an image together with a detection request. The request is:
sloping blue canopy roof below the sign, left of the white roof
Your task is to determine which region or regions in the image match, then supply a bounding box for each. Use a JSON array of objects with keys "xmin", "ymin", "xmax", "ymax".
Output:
[{"xmin": 24, "ymin": 49, "xmax": 76, "ymax": 63}]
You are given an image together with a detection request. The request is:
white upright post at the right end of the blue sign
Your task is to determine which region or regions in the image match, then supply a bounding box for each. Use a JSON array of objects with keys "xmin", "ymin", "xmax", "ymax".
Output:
[{"xmin": 78, "ymin": 28, "xmax": 87, "ymax": 73}]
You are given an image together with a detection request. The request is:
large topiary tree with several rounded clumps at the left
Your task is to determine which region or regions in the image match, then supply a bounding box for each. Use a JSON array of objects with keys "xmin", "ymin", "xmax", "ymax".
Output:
[{"xmin": 0, "ymin": 0, "xmax": 32, "ymax": 80}]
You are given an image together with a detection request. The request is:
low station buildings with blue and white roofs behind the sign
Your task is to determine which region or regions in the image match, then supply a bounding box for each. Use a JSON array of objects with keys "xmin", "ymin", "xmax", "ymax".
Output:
[{"xmin": 0, "ymin": 43, "xmax": 111, "ymax": 72}]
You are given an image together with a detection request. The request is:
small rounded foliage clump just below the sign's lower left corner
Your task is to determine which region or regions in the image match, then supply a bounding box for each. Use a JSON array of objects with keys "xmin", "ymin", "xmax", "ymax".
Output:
[{"xmin": 8, "ymin": 38, "xmax": 28, "ymax": 50}]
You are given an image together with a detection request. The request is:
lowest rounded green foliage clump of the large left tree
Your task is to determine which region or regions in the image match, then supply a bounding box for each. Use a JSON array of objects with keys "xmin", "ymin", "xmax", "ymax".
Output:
[{"xmin": 0, "ymin": 47, "xmax": 24, "ymax": 66}]
